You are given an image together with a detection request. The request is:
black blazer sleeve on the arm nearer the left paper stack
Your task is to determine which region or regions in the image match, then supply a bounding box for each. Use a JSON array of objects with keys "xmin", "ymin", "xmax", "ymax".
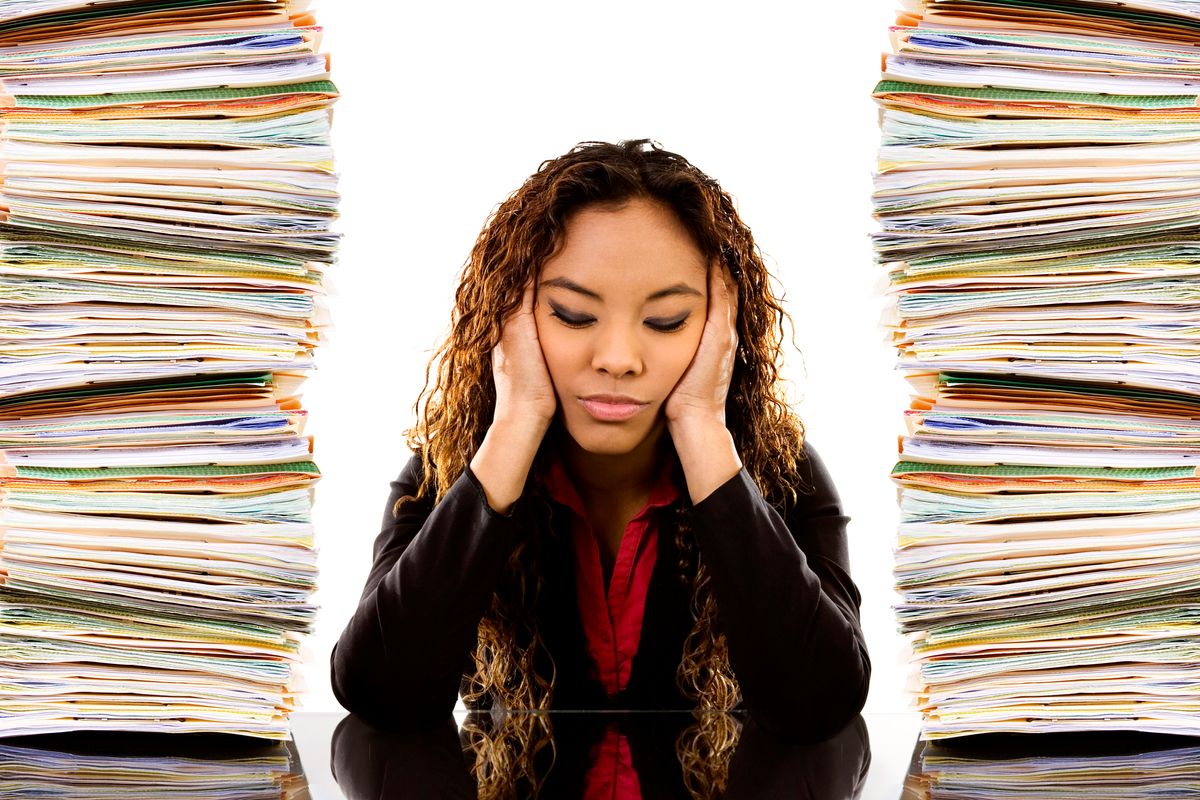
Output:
[{"xmin": 330, "ymin": 456, "xmax": 523, "ymax": 729}]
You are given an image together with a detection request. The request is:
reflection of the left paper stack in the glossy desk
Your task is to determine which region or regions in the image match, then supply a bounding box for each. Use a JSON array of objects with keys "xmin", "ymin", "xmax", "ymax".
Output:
[{"xmin": 0, "ymin": 732, "xmax": 308, "ymax": 800}]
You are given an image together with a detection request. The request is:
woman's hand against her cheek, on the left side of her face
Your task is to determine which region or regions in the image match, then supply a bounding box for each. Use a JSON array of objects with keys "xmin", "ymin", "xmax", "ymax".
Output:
[{"xmin": 492, "ymin": 278, "xmax": 558, "ymax": 432}]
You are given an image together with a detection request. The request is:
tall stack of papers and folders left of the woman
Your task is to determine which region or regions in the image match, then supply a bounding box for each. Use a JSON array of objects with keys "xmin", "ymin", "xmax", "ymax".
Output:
[{"xmin": 0, "ymin": 0, "xmax": 337, "ymax": 739}]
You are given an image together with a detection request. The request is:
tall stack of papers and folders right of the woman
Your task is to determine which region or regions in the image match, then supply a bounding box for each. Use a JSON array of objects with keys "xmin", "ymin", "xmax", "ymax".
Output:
[{"xmin": 874, "ymin": 0, "xmax": 1200, "ymax": 739}]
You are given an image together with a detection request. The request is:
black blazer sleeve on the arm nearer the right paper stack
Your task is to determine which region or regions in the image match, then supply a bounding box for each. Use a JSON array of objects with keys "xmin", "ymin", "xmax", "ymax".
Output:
[{"xmin": 692, "ymin": 443, "xmax": 871, "ymax": 739}]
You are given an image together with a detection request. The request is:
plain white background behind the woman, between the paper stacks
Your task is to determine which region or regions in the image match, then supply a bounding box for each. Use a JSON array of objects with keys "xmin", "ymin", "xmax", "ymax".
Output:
[{"xmin": 304, "ymin": 0, "xmax": 908, "ymax": 711}]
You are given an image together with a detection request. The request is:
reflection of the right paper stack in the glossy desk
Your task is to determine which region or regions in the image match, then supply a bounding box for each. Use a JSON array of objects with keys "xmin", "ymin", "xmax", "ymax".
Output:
[{"xmin": 904, "ymin": 732, "xmax": 1200, "ymax": 800}]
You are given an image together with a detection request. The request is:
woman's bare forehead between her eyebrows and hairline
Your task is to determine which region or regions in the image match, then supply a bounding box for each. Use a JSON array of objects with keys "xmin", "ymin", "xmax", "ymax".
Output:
[{"xmin": 541, "ymin": 198, "xmax": 708, "ymax": 289}]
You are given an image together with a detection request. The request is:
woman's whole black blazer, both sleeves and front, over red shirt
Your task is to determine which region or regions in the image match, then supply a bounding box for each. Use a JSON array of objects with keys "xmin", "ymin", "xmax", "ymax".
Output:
[{"xmin": 330, "ymin": 443, "xmax": 871, "ymax": 739}]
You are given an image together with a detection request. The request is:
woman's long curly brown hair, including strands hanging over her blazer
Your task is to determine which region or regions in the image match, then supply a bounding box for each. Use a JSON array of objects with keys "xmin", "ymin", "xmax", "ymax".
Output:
[{"xmin": 394, "ymin": 139, "xmax": 804, "ymax": 796}]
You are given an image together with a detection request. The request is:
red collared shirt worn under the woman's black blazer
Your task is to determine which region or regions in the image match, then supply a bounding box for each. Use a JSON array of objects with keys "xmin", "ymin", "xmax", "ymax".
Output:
[{"xmin": 545, "ymin": 453, "xmax": 679, "ymax": 697}]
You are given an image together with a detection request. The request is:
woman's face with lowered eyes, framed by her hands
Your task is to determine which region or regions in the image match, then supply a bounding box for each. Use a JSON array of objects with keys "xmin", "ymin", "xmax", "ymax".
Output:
[{"xmin": 534, "ymin": 199, "xmax": 708, "ymax": 455}]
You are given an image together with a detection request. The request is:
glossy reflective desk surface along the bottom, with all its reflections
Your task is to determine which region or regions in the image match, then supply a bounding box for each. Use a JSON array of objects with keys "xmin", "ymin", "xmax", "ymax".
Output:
[{"xmin": 0, "ymin": 712, "xmax": 1200, "ymax": 800}]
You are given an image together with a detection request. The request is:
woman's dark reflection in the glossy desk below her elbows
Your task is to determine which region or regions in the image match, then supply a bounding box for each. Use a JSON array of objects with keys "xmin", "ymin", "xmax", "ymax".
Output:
[{"xmin": 330, "ymin": 711, "xmax": 871, "ymax": 800}]
